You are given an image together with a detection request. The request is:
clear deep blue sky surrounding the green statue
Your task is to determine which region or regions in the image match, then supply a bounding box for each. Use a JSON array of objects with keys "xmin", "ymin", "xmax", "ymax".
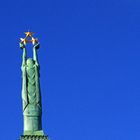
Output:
[{"xmin": 0, "ymin": 0, "xmax": 140, "ymax": 140}]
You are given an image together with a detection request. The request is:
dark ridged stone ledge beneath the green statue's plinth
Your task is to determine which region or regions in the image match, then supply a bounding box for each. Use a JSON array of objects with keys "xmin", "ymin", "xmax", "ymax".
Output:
[{"xmin": 20, "ymin": 135, "xmax": 48, "ymax": 140}]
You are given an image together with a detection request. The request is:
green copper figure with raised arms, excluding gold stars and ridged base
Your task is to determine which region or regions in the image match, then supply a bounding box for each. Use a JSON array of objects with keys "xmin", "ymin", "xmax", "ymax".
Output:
[{"xmin": 20, "ymin": 42, "xmax": 43, "ymax": 134}]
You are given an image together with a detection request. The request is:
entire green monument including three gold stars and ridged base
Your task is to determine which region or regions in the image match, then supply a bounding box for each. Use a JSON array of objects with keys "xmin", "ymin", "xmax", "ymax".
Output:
[{"xmin": 20, "ymin": 31, "xmax": 48, "ymax": 140}]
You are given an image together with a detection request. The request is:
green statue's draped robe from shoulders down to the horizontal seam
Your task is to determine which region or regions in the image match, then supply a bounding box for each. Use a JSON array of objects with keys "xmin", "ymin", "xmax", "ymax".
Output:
[{"xmin": 22, "ymin": 63, "xmax": 41, "ymax": 117}]
